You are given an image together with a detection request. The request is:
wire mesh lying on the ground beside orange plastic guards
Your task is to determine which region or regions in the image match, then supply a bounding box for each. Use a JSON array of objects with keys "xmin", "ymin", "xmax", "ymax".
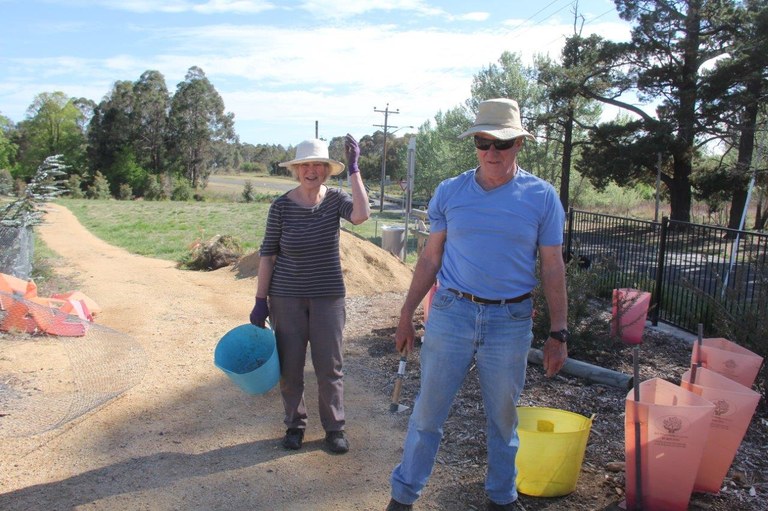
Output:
[{"xmin": 0, "ymin": 293, "xmax": 146, "ymax": 437}]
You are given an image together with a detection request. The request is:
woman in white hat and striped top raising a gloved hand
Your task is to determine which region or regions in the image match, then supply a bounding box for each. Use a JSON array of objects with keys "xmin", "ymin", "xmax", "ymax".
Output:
[{"xmin": 250, "ymin": 135, "xmax": 371, "ymax": 454}]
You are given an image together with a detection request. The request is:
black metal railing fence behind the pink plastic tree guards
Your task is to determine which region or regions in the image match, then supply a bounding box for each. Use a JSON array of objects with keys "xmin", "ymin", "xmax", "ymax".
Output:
[{"xmin": 565, "ymin": 209, "xmax": 768, "ymax": 335}]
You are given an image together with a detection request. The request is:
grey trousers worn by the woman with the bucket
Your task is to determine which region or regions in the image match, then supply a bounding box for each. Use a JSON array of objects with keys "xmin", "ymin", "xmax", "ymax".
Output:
[{"xmin": 269, "ymin": 296, "xmax": 346, "ymax": 431}]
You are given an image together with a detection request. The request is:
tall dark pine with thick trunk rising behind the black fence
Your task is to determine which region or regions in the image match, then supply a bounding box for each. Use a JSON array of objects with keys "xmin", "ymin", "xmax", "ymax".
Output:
[{"xmin": 577, "ymin": 0, "xmax": 734, "ymax": 221}]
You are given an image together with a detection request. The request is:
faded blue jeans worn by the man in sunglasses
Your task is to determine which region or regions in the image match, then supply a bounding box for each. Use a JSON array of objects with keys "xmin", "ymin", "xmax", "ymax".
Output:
[{"xmin": 391, "ymin": 289, "xmax": 533, "ymax": 504}]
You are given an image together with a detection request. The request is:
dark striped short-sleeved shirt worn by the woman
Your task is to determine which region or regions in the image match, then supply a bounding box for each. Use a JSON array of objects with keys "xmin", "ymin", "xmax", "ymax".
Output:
[{"xmin": 259, "ymin": 188, "xmax": 352, "ymax": 298}]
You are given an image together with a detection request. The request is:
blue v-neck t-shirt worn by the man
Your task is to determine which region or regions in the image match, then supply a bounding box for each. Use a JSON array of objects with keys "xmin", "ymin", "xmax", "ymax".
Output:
[{"xmin": 429, "ymin": 167, "xmax": 565, "ymax": 300}]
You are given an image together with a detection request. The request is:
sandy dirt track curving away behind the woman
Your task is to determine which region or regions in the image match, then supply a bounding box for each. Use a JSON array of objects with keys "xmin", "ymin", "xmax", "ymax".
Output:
[{"xmin": 0, "ymin": 206, "xmax": 426, "ymax": 511}]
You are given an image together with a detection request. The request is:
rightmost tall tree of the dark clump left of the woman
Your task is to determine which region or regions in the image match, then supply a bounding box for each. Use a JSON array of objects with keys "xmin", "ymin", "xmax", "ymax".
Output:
[{"xmin": 168, "ymin": 66, "xmax": 236, "ymax": 188}]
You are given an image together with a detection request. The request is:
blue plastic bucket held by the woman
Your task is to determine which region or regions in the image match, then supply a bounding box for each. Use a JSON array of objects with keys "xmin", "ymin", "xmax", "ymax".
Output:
[{"xmin": 213, "ymin": 323, "xmax": 280, "ymax": 394}]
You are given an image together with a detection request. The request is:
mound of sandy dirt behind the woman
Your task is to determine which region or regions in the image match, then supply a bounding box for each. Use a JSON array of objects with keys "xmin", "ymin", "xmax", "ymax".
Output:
[{"xmin": 232, "ymin": 231, "xmax": 413, "ymax": 296}]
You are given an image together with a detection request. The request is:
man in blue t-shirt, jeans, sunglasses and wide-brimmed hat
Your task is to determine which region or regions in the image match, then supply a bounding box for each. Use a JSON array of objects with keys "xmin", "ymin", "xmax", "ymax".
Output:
[{"xmin": 387, "ymin": 99, "xmax": 568, "ymax": 511}]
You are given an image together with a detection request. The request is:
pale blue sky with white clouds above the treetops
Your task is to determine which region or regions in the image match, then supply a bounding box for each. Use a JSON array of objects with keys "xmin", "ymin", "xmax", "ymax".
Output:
[{"xmin": 0, "ymin": 0, "xmax": 629, "ymax": 146}]
